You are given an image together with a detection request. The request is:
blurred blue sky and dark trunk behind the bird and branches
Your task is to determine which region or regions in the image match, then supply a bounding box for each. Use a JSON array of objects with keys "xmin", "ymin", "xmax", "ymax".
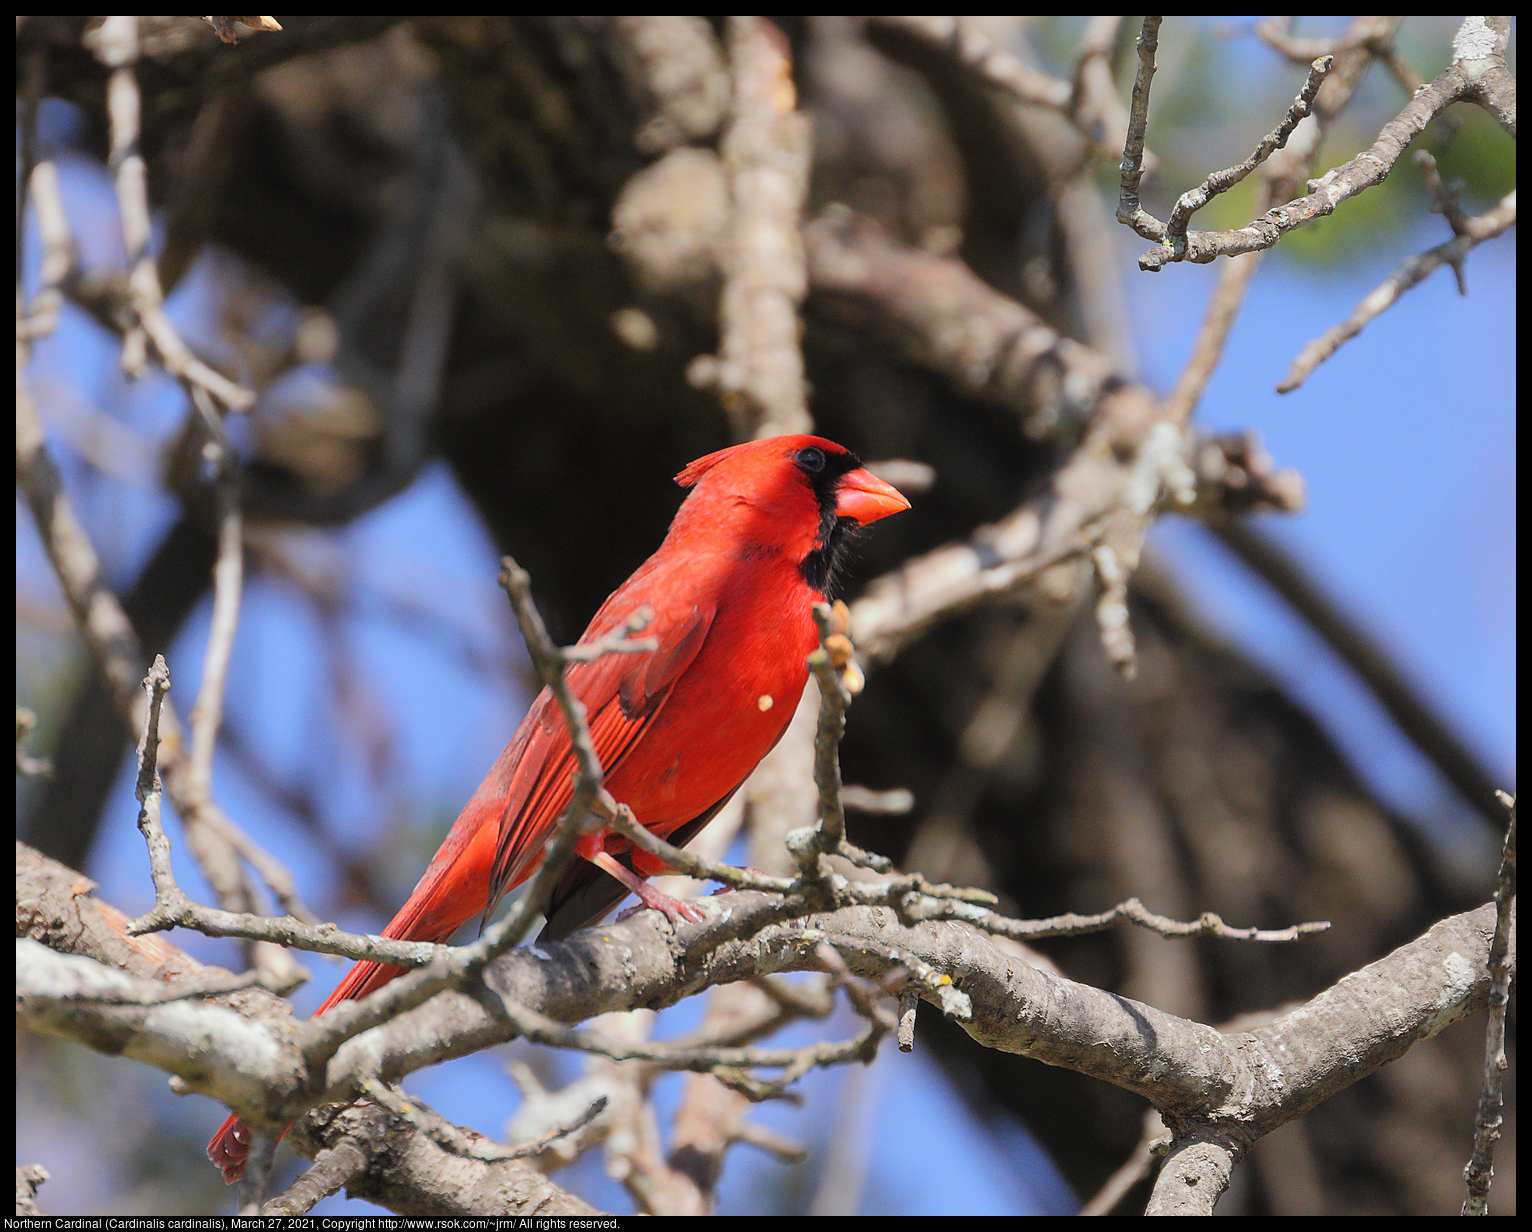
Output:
[{"xmin": 17, "ymin": 17, "xmax": 1515, "ymax": 1215}]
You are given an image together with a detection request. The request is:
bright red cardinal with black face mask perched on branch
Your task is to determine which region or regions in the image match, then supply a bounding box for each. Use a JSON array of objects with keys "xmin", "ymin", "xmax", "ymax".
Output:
[{"xmin": 207, "ymin": 437, "xmax": 910, "ymax": 1183}]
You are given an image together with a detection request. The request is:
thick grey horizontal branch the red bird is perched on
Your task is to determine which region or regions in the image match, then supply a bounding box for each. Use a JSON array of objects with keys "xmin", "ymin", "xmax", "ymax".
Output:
[{"xmin": 17, "ymin": 895, "xmax": 1495, "ymax": 1164}]
